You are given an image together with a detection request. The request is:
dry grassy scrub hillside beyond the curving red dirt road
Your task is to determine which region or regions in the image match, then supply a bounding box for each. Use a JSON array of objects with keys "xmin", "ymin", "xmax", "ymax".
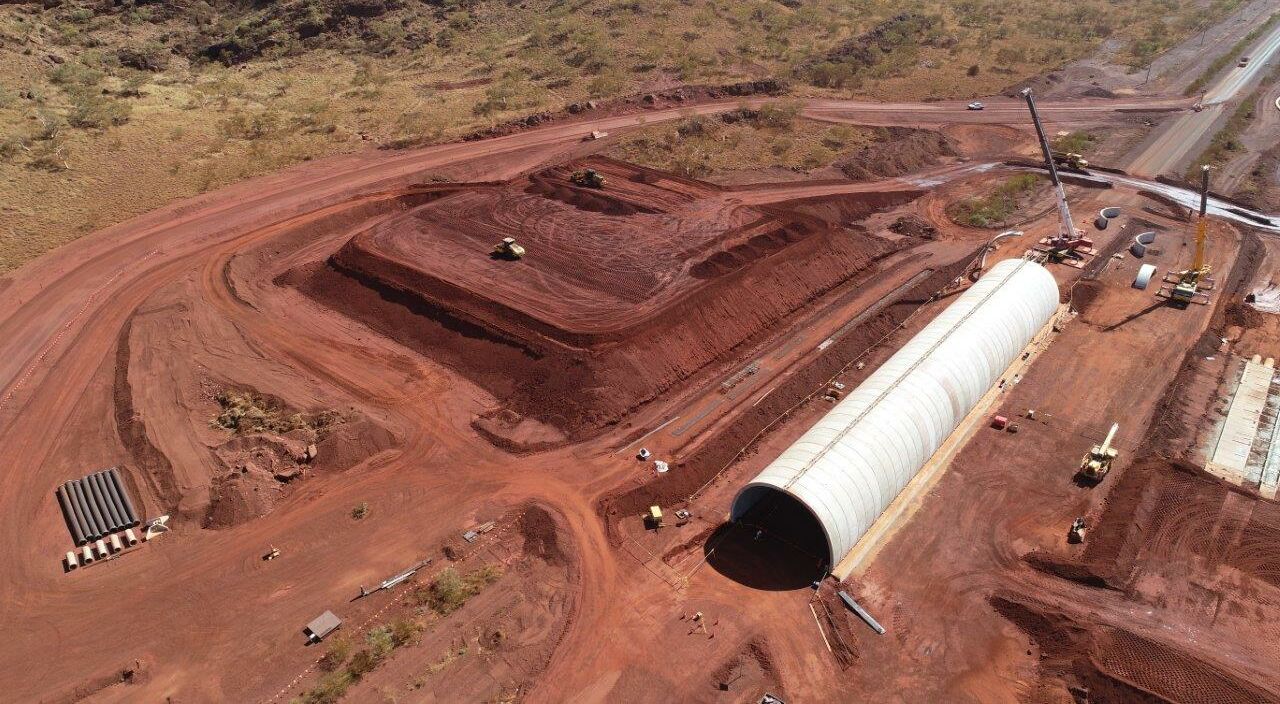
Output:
[{"xmin": 0, "ymin": 0, "xmax": 1239, "ymax": 274}]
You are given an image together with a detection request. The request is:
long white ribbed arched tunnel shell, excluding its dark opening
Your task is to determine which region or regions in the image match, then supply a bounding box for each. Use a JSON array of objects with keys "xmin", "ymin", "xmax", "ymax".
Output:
[{"xmin": 731, "ymin": 259, "xmax": 1059, "ymax": 570}]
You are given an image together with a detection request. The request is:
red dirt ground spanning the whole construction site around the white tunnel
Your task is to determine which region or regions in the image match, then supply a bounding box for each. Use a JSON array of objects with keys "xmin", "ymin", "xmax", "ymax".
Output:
[{"xmin": 0, "ymin": 84, "xmax": 1280, "ymax": 703}]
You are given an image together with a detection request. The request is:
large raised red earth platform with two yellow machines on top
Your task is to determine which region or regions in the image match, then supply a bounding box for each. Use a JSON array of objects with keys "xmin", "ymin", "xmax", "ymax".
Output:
[{"xmin": 296, "ymin": 157, "xmax": 920, "ymax": 449}]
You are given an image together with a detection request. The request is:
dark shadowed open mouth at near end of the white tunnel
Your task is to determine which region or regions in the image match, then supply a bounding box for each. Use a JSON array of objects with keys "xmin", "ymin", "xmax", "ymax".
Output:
[{"xmin": 703, "ymin": 486, "xmax": 831, "ymax": 591}]
